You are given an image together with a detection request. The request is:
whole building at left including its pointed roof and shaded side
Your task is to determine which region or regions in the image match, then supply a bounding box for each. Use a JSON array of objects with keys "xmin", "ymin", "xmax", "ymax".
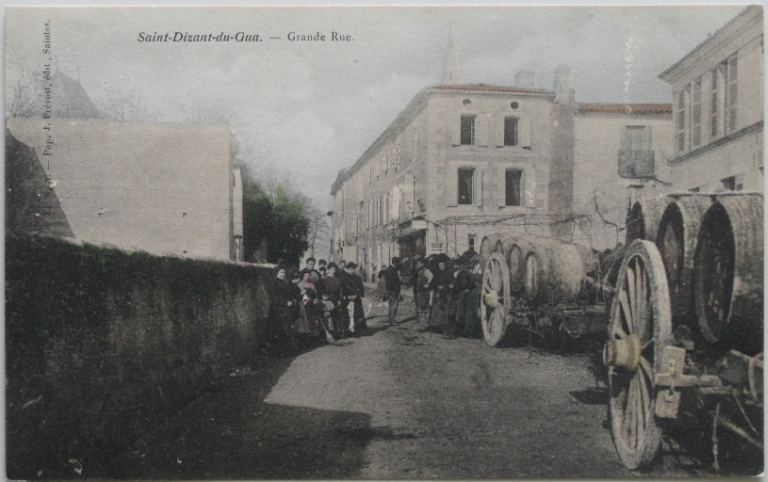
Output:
[{"xmin": 6, "ymin": 70, "xmax": 243, "ymax": 261}]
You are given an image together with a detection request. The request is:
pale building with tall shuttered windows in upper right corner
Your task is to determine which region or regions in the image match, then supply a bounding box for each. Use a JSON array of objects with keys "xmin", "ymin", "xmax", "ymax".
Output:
[{"xmin": 660, "ymin": 6, "xmax": 764, "ymax": 192}]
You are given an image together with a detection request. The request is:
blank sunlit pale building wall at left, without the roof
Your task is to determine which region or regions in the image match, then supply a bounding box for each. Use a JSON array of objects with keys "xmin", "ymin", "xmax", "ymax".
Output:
[{"xmin": 6, "ymin": 118, "xmax": 242, "ymax": 260}]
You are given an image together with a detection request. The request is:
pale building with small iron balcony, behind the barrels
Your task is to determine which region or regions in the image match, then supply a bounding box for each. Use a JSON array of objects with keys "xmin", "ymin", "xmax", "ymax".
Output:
[{"xmin": 568, "ymin": 104, "xmax": 673, "ymax": 250}]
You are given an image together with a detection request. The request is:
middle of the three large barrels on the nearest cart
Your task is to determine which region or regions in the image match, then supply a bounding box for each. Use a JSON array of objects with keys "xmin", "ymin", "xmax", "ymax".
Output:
[{"xmin": 656, "ymin": 194, "xmax": 712, "ymax": 323}]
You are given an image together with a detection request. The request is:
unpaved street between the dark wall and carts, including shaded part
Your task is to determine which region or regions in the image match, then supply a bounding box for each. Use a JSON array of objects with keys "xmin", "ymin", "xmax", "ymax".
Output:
[{"xmin": 115, "ymin": 304, "xmax": 704, "ymax": 479}]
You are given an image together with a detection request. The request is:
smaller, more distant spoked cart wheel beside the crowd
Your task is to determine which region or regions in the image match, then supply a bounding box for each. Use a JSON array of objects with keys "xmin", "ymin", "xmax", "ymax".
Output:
[{"xmin": 480, "ymin": 253, "xmax": 512, "ymax": 346}]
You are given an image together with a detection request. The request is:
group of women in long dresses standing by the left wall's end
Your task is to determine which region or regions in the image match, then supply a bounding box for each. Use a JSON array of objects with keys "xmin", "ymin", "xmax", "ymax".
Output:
[{"xmin": 267, "ymin": 258, "xmax": 367, "ymax": 354}]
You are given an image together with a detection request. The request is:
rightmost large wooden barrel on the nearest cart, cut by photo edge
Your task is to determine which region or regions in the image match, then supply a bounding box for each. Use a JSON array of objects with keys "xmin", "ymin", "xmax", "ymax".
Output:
[{"xmin": 693, "ymin": 193, "xmax": 764, "ymax": 356}]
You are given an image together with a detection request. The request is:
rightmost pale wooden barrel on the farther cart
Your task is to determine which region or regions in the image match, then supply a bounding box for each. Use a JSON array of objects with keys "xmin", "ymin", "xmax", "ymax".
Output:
[{"xmin": 510, "ymin": 237, "xmax": 597, "ymax": 306}]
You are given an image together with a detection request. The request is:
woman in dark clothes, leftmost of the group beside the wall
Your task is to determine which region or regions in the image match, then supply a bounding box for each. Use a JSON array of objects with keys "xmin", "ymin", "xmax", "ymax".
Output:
[{"xmin": 267, "ymin": 266, "xmax": 300, "ymax": 354}]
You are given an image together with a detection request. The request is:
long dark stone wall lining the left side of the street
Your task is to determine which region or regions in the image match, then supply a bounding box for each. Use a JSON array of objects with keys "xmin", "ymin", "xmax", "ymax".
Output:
[{"xmin": 5, "ymin": 235, "xmax": 272, "ymax": 480}]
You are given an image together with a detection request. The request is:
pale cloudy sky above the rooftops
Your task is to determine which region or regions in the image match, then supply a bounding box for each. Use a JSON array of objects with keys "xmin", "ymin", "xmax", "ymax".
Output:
[{"xmin": 6, "ymin": 4, "xmax": 744, "ymax": 209}]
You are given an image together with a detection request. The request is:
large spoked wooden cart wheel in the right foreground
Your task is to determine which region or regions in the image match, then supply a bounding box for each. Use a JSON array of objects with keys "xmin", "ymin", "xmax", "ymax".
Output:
[{"xmin": 603, "ymin": 240, "xmax": 672, "ymax": 470}]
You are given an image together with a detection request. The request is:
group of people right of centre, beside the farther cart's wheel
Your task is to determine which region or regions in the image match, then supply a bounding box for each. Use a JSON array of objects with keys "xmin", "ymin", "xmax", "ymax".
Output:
[{"xmin": 379, "ymin": 248, "xmax": 481, "ymax": 338}]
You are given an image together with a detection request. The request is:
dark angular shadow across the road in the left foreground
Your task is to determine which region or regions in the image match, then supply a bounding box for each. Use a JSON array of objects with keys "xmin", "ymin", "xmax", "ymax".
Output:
[{"xmin": 112, "ymin": 350, "xmax": 377, "ymax": 480}]
